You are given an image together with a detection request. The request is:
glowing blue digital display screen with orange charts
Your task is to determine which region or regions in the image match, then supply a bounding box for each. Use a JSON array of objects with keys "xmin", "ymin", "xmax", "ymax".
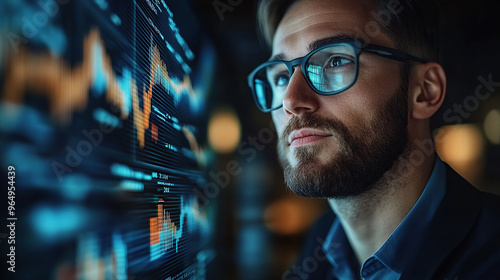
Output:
[{"xmin": 0, "ymin": 0, "xmax": 215, "ymax": 280}]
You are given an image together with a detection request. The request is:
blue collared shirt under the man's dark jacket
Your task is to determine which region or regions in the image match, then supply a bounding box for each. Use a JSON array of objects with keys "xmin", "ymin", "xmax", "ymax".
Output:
[{"xmin": 323, "ymin": 156, "xmax": 446, "ymax": 280}]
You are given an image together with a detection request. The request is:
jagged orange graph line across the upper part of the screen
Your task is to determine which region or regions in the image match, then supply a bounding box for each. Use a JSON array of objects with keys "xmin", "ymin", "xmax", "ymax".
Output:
[{"xmin": 3, "ymin": 29, "xmax": 196, "ymax": 148}]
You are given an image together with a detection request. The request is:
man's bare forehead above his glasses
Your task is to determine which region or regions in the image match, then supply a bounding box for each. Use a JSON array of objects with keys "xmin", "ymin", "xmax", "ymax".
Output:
[{"xmin": 273, "ymin": 0, "xmax": 392, "ymax": 59}]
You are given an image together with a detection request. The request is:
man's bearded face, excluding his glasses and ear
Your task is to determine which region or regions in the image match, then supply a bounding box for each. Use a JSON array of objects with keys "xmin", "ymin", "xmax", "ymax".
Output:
[{"xmin": 272, "ymin": 0, "xmax": 408, "ymax": 198}]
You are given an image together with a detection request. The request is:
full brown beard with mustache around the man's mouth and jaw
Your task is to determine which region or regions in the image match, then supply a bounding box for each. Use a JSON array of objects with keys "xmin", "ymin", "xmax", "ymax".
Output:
[{"xmin": 278, "ymin": 74, "xmax": 409, "ymax": 198}]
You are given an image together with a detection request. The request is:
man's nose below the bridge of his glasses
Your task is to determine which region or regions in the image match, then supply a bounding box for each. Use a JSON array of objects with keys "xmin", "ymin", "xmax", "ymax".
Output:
[{"xmin": 283, "ymin": 66, "xmax": 319, "ymax": 115}]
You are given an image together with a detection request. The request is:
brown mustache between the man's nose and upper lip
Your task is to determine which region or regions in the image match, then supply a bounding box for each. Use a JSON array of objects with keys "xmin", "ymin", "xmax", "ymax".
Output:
[{"xmin": 280, "ymin": 114, "xmax": 352, "ymax": 143}]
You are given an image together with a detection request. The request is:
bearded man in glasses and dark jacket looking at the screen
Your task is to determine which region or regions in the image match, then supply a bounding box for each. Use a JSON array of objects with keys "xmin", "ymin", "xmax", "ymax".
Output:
[{"xmin": 248, "ymin": 0, "xmax": 500, "ymax": 279}]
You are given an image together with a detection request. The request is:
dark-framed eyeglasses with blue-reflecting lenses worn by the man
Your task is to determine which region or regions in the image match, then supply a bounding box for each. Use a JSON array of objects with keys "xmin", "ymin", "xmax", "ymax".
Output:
[{"xmin": 248, "ymin": 41, "xmax": 427, "ymax": 112}]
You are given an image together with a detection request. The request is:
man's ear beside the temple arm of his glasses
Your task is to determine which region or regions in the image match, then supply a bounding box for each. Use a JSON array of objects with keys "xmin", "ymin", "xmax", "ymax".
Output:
[{"xmin": 408, "ymin": 62, "xmax": 446, "ymax": 119}]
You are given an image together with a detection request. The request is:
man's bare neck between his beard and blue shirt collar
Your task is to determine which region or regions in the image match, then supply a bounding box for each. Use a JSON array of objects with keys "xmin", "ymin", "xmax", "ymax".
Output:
[{"xmin": 329, "ymin": 148, "xmax": 435, "ymax": 264}]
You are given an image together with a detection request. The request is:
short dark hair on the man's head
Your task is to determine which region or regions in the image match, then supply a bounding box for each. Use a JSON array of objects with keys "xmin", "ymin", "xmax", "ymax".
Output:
[{"xmin": 257, "ymin": 0, "xmax": 440, "ymax": 61}]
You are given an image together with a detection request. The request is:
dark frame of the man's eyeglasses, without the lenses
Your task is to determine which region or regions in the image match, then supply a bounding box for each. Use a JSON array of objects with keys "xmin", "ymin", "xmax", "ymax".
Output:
[{"xmin": 247, "ymin": 41, "xmax": 428, "ymax": 113}]
